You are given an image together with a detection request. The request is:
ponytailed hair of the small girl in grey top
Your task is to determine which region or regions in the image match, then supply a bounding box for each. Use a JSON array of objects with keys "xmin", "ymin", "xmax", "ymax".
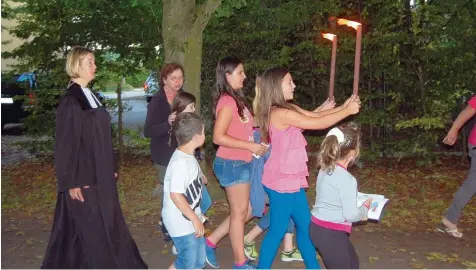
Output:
[{"xmin": 317, "ymin": 122, "xmax": 360, "ymax": 174}]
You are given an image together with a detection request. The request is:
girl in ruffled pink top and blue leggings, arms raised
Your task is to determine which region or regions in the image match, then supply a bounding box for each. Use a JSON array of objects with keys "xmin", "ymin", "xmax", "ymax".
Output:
[{"xmin": 255, "ymin": 68, "xmax": 360, "ymax": 269}]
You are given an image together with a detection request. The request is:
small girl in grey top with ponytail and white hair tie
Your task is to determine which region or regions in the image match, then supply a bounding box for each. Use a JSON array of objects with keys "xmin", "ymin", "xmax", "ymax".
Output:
[{"xmin": 309, "ymin": 122, "xmax": 371, "ymax": 269}]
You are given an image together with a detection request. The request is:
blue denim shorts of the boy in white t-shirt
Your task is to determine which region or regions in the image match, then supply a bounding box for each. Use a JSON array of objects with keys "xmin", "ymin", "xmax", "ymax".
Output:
[{"xmin": 172, "ymin": 233, "xmax": 206, "ymax": 269}]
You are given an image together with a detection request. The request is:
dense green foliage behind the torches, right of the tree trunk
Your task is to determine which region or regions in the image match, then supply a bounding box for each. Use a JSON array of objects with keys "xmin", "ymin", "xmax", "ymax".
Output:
[{"xmin": 201, "ymin": 0, "xmax": 476, "ymax": 160}]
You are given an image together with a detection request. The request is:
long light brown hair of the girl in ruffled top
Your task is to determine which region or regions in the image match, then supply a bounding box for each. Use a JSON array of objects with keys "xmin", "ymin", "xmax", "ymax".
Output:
[{"xmin": 255, "ymin": 67, "xmax": 296, "ymax": 143}]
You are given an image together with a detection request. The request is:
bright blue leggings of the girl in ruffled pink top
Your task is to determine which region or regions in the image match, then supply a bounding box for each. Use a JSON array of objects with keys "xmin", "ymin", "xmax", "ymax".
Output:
[{"xmin": 258, "ymin": 187, "xmax": 321, "ymax": 269}]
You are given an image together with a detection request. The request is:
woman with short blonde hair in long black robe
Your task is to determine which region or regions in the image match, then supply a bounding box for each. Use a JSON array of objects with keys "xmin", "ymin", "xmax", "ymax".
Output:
[{"xmin": 42, "ymin": 47, "xmax": 147, "ymax": 268}]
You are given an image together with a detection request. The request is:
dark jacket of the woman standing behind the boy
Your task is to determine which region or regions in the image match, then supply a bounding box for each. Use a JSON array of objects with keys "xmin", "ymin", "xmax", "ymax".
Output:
[{"xmin": 144, "ymin": 89, "xmax": 177, "ymax": 166}]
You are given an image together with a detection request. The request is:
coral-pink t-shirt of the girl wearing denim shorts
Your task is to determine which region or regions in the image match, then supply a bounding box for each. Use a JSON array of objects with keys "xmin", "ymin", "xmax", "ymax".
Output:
[{"xmin": 216, "ymin": 95, "xmax": 253, "ymax": 162}]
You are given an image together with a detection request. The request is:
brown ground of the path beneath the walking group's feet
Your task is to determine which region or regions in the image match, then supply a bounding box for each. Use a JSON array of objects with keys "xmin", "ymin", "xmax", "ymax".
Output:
[{"xmin": 1, "ymin": 216, "xmax": 476, "ymax": 269}]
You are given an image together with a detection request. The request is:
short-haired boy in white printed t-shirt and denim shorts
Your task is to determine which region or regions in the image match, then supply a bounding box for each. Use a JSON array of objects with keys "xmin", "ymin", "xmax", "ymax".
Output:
[{"xmin": 162, "ymin": 113, "xmax": 205, "ymax": 269}]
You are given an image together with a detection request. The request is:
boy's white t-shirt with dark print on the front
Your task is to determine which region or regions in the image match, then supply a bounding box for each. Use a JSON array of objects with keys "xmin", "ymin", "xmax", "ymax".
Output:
[{"xmin": 162, "ymin": 149, "xmax": 202, "ymax": 237}]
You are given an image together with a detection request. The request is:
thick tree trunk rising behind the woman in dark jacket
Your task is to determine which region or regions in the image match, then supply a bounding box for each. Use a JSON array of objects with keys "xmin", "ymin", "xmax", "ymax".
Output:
[{"xmin": 162, "ymin": 0, "xmax": 221, "ymax": 113}]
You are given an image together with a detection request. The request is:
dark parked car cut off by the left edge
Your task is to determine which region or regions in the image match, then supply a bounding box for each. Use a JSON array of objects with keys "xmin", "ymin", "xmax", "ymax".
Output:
[{"xmin": 1, "ymin": 72, "xmax": 105, "ymax": 130}]
